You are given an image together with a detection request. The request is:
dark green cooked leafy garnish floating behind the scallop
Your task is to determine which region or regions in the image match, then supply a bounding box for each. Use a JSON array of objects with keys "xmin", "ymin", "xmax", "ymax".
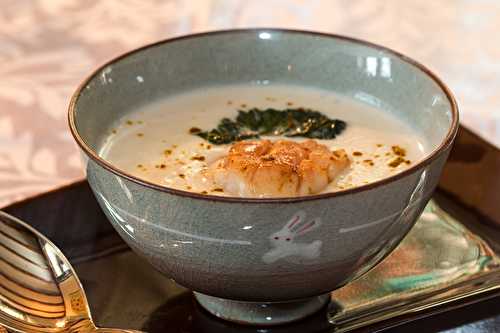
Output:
[{"xmin": 192, "ymin": 108, "xmax": 347, "ymax": 145}]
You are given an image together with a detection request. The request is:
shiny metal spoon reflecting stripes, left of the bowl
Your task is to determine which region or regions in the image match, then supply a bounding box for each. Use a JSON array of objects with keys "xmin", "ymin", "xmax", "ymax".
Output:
[{"xmin": 0, "ymin": 211, "xmax": 138, "ymax": 333}]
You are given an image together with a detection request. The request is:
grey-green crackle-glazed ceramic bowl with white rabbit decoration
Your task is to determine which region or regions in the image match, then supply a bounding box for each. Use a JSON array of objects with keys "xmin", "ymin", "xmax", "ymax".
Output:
[{"xmin": 69, "ymin": 29, "xmax": 458, "ymax": 324}]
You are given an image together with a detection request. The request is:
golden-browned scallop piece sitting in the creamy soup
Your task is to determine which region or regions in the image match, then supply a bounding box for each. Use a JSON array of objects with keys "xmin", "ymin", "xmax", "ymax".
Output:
[{"xmin": 211, "ymin": 140, "xmax": 349, "ymax": 196}]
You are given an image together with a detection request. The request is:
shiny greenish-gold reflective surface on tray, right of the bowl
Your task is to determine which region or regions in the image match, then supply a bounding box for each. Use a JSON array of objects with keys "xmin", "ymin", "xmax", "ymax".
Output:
[{"xmin": 329, "ymin": 201, "xmax": 500, "ymax": 332}]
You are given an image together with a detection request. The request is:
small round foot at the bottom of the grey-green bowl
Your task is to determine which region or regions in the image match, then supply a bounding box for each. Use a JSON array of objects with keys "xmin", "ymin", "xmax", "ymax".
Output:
[{"xmin": 194, "ymin": 292, "xmax": 330, "ymax": 326}]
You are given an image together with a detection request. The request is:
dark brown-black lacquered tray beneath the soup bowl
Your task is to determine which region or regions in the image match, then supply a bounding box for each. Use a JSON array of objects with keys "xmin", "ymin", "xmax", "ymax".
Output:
[{"xmin": 4, "ymin": 128, "xmax": 500, "ymax": 333}]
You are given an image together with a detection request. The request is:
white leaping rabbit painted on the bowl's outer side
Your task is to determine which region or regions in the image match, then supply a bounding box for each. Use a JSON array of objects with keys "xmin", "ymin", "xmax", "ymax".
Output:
[{"xmin": 262, "ymin": 211, "xmax": 322, "ymax": 264}]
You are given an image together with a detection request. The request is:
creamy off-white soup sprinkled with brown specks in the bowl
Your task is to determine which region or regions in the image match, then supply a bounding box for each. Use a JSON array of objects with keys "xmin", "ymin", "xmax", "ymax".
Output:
[{"xmin": 99, "ymin": 85, "xmax": 428, "ymax": 197}]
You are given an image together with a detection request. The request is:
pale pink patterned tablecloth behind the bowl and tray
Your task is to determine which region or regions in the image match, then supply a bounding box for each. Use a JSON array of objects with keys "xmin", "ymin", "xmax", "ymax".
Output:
[{"xmin": 0, "ymin": 0, "xmax": 500, "ymax": 206}]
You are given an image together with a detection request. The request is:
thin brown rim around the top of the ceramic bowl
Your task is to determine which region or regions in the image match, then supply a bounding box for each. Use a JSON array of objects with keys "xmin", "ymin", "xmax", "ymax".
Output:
[{"xmin": 68, "ymin": 28, "xmax": 459, "ymax": 203}]
